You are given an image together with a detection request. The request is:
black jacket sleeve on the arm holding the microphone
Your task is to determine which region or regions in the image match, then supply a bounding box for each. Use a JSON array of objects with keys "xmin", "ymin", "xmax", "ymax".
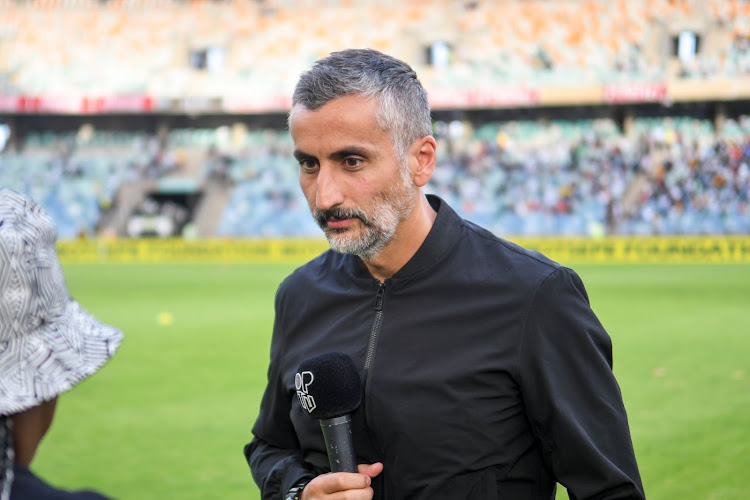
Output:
[{"xmin": 244, "ymin": 288, "xmax": 315, "ymax": 500}]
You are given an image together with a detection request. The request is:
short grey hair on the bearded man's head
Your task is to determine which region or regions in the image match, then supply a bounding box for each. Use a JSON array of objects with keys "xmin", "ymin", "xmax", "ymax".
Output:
[{"xmin": 292, "ymin": 49, "xmax": 432, "ymax": 161}]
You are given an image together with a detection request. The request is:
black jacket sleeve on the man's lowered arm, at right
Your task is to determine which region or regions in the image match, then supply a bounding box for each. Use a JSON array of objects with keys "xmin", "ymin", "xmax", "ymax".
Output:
[{"xmin": 519, "ymin": 268, "xmax": 645, "ymax": 500}]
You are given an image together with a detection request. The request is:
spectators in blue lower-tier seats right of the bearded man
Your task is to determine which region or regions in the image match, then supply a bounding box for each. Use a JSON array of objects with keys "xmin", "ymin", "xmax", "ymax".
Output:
[{"xmin": 420, "ymin": 117, "xmax": 750, "ymax": 236}]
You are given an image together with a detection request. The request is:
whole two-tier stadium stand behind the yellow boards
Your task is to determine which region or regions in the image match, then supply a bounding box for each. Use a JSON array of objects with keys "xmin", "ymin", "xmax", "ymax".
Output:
[{"xmin": 0, "ymin": 0, "xmax": 750, "ymax": 238}]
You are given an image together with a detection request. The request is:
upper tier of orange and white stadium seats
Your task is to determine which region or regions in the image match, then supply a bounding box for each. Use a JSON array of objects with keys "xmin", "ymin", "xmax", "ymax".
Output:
[{"xmin": 0, "ymin": 0, "xmax": 750, "ymax": 99}]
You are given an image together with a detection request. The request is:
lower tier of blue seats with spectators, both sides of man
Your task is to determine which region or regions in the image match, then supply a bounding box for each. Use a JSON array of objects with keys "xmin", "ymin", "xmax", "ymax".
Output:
[{"xmin": 0, "ymin": 116, "xmax": 750, "ymax": 237}]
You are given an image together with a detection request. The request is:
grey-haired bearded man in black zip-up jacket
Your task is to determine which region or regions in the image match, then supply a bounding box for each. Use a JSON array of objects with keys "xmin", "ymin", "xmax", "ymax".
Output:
[{"xmin": 245, "ymin": 50, "xmax": 644, "ymax": 500}]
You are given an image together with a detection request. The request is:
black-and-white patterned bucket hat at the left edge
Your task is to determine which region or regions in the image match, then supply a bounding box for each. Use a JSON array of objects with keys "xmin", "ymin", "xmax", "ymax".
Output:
[{"xmin": 0, "ymin": 188, "xmax": 122, "ymax": 415}]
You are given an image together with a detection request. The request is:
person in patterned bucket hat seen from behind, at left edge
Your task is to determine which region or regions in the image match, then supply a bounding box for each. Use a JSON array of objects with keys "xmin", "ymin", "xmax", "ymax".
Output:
[{"xmin": 0, "ymin": 188, "xmax": 122, "ymax": 500}]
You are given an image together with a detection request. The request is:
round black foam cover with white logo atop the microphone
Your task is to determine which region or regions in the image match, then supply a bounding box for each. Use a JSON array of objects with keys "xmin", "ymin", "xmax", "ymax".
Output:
[{"xmin": 294, "ymin": 352, "xmax": 362, "ymax": 420}]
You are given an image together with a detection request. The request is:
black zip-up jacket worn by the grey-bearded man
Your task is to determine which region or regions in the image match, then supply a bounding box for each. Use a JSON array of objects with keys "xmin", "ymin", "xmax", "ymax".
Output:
[{"xmin": 245, "ymin": 196, "xmax": 644, "ymax": 500}]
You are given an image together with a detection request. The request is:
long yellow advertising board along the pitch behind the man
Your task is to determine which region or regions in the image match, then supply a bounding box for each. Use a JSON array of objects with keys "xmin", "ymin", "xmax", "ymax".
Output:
[{"xmin": 57, "ymin": 235, "xmax": 750, "ymax": 264}]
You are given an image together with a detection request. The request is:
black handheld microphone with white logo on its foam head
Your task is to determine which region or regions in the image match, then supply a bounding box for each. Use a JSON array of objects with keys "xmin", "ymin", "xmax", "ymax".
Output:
[{"xmin": 294, "ymin": 352, "xmax": 362, "ymax": 472}]
